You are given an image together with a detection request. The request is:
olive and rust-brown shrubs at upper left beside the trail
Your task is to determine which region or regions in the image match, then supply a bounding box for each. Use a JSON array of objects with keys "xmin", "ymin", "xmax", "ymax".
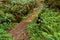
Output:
[{"xmin": 0, "ymin": 0, "xmax": 35, "ymax": 22}]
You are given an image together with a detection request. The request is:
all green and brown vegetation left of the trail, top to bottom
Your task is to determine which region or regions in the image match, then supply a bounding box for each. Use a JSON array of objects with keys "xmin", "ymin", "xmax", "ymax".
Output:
[{"xmin": 0, "ymin": 0, "xmax": 36, "ymax": 40}]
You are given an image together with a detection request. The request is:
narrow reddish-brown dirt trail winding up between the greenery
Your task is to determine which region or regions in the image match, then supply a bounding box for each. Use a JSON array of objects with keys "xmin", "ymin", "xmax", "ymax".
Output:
[{"xmin": 8, "ymin": 0, "xmax": 42, "ymax": 40}]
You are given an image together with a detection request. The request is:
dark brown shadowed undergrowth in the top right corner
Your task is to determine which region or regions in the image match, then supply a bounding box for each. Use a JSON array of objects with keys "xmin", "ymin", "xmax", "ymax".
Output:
[{"xmin": 44, "ymin": 0, "xmax": 60, "ymax": 10}]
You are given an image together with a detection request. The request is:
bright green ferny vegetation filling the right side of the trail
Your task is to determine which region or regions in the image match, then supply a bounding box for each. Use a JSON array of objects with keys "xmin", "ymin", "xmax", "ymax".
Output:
[{"xmin": 27, "ymin": 0, "xmax": 60, "ymax": 40}]
